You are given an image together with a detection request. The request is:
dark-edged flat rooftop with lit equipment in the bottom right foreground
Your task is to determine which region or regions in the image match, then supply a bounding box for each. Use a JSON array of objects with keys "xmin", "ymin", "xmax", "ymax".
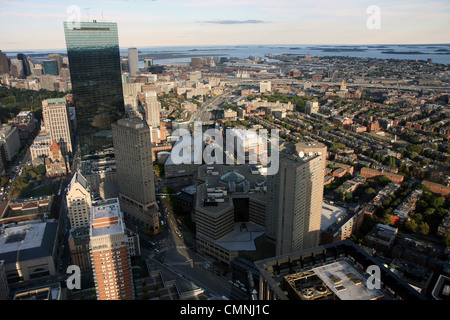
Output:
[{"xmin": 255, "ymin": 240, "xmax": 426, "ymax": 301}]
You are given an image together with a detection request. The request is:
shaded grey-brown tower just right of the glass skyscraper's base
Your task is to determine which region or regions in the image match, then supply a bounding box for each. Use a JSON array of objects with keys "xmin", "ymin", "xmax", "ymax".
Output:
[{"xmin": 112, "ymin": 118, "xmax": 159, "ymax": 230}]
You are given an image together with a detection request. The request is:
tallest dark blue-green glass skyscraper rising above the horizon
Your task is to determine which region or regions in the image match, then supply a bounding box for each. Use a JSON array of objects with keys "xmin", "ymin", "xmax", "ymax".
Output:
[{"xmin": 64, "ymin": 21, "xmax": 125, "ymax": 159}]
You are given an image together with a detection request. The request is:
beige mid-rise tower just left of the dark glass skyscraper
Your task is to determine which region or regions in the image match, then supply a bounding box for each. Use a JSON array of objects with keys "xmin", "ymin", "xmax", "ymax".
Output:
[{"xmin": 42, "ymin": 98, "xmax": 73, "ymax": 156}]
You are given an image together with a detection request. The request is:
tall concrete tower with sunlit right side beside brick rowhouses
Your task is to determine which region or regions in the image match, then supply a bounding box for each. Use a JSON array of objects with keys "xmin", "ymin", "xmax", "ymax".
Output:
[{"xmin": 266, "ymin": 142, "xmax": 327, "ymax": 255}]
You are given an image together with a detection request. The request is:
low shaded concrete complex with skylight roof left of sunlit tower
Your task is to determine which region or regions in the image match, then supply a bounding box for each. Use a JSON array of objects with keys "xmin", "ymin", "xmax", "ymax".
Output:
[{"xmin": 194, "ymin": 164, "xmax": 266, "ymax": 265}]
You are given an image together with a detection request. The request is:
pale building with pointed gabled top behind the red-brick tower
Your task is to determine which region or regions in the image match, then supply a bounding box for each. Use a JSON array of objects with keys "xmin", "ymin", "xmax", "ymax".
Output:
[{"xmin": 66, "ymin": 172, "xmax": 92, "ymax": 229}]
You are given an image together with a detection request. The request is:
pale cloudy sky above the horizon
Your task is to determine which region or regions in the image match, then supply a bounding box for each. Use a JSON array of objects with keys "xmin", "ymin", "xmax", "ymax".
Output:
[{"xmin": 0, "ymin": 0, "xmax": 450, "ymax": 51}]
